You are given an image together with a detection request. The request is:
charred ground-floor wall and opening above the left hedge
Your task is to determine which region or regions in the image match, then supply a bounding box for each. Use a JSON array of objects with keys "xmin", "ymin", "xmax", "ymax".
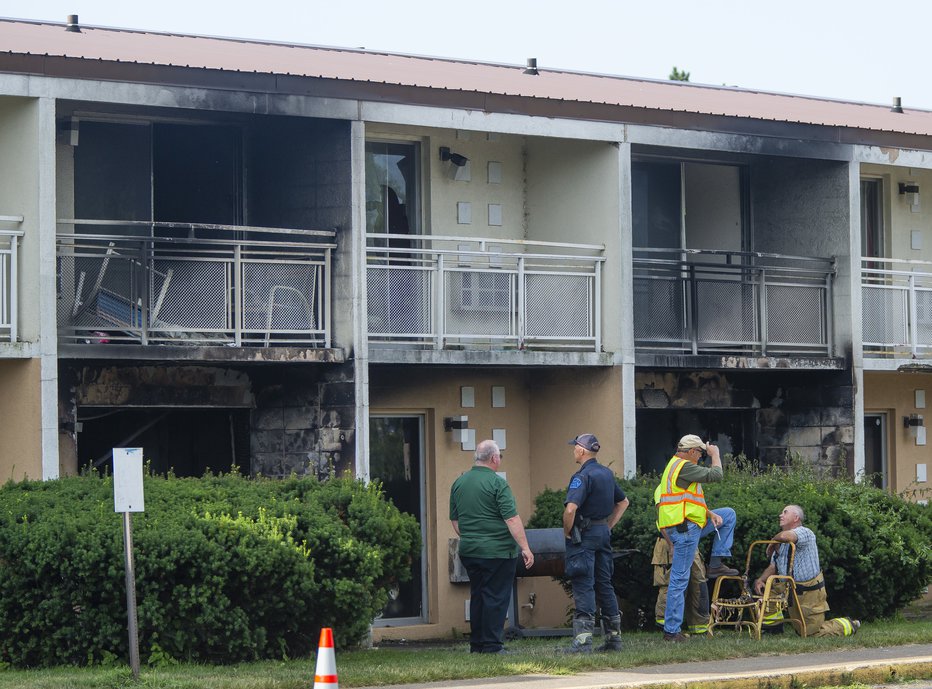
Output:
[{"xmin": 59, "ymin": 363, "xmax": 355, "ymax": 477}]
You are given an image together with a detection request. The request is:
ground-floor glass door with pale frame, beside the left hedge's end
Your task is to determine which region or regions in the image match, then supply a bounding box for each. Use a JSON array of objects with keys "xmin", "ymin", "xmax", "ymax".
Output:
[{"xmin": 369, "ymin": 415, "xmax": 427, "ymax": 626}]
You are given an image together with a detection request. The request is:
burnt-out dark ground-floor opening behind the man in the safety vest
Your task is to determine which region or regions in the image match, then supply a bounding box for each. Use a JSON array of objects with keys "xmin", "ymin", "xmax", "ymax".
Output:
[{"xmin": 635, "ymin": 409, "xmax": 757, "ymax": 474}]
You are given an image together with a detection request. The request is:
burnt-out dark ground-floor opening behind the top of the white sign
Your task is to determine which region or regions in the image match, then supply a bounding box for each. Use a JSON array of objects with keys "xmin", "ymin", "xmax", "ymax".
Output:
[{"xmin": 78, "ymin": 407, "xmax": 250, "ymax": 477}]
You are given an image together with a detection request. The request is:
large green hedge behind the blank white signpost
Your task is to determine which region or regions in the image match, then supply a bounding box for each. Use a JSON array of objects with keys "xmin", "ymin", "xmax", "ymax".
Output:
[{"xmin": 0, "ymin": 475, "xmax": 420, "ymax": 667}]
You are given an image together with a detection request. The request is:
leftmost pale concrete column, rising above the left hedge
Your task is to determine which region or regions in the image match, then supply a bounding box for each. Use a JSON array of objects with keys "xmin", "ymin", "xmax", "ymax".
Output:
[{"xmin": 36, "ymin": 98, "xmax": 59, "ymax": 480}]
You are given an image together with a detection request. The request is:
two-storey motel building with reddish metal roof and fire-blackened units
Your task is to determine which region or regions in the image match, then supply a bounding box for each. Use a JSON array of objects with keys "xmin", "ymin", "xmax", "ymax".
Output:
[{"xmin": 0, "ymin": 17, "xmax": 932, "ymax": 638}]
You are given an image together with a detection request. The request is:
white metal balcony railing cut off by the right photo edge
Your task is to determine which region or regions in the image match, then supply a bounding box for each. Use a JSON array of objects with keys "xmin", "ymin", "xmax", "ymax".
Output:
[{"xmin": 861, "ymin": 257, "xmax": 932, "ymax": 358}]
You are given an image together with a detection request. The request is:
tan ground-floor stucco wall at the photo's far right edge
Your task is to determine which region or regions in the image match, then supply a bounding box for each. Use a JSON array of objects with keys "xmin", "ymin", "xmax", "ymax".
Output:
[{"xmin": 864, "ymin": 371, "xmax": 932, "ymax": 499}]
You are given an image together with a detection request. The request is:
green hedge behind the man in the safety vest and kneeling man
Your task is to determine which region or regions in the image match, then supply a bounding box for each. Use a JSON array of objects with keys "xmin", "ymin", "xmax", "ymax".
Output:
[{"xmin": 528, "ymin": 467, "xmax": 932, "ymax": 626}]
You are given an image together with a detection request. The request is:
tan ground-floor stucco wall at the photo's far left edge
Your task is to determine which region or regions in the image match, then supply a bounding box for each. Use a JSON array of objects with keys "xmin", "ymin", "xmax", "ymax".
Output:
[{"xmin": 0, "ymin": 359, "xmax": 42, "ymax": 483}]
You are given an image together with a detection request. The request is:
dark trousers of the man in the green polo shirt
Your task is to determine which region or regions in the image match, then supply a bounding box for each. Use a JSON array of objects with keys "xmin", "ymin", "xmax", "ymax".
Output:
[{"xmin": 460, "ymin": 557, "xmax": 518, "ymax": 653}]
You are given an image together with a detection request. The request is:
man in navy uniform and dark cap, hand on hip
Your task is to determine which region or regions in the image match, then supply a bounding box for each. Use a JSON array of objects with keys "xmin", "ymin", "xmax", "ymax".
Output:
[{"xmin": 563, "ymin": 433, "xmax": 628, "ymax": 653}]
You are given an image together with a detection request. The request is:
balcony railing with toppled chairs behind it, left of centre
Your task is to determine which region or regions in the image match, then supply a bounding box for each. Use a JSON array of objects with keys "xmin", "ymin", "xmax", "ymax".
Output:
[{"xmin": 57, "ymin": 219, "xmax": 336, "ymax": 347}]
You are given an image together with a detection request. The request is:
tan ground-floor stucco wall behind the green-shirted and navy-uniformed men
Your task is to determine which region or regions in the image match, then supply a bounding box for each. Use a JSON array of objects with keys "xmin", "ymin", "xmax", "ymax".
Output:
[{"xmin": 369, "ymin": 367, "xmax": 622, "ymax": 638}]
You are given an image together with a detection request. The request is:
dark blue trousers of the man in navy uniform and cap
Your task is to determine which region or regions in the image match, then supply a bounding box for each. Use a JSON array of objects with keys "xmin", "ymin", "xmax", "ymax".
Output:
[{"xmin": 566, "ymin": 524, "xmax": 618, "ymax": 619}]
